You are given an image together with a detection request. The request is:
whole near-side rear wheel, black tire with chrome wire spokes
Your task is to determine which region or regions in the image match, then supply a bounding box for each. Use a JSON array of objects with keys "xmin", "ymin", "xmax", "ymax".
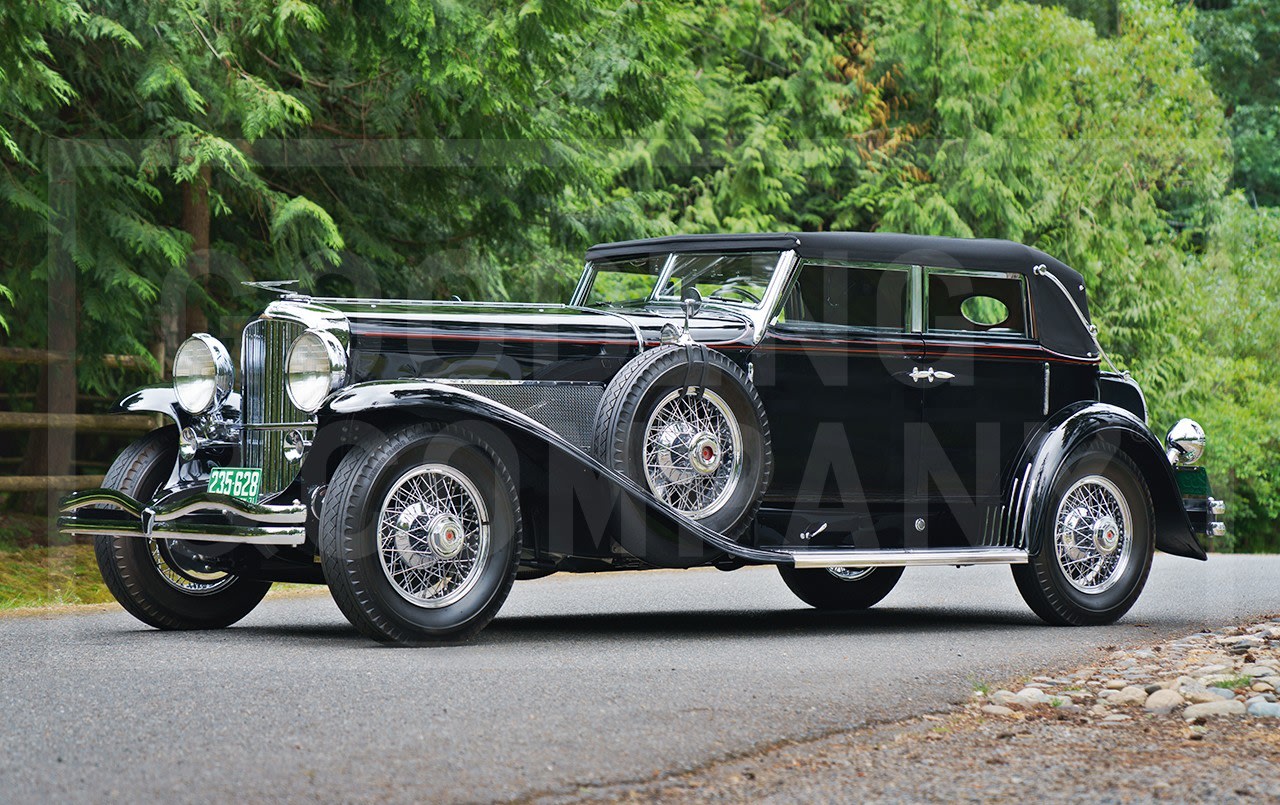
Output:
[{"xmin": 1012, "ymin": 440, "xmax": 1156, "ymax": 626}]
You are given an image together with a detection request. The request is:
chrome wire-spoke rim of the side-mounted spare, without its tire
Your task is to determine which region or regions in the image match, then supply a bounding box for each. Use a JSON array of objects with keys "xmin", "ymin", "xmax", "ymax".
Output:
[{"xmin": 643, "ymin": 388, "xmax": 742, "ymax": 518}]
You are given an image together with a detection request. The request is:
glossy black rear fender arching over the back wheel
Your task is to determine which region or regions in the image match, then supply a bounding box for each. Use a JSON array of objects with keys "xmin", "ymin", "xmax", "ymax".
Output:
[{"xmin": 1006, "ymin": 402, "xmax": 1208, "ymax": 559}]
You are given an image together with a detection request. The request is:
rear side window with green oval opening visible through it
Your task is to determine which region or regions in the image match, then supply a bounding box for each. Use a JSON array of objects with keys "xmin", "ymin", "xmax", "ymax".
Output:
[{"xmin": 925, "ymin": 269, "xmax": 1030, "ymax": 337}]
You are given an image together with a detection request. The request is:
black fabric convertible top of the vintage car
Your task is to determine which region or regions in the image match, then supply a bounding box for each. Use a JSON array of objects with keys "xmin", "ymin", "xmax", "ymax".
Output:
[{"xmin": 586, "ymin": 232, "xmax": 1098, "ymax": 358}]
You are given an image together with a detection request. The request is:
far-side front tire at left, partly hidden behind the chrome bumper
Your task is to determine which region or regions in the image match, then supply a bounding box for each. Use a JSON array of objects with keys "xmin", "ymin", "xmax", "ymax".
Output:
[{"xmin": 93, "ymin": 427, "xmax": 271, "ymax": 630}]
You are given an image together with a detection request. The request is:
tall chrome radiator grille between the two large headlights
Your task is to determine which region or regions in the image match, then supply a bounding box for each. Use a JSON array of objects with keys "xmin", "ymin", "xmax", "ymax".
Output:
[{"xmin": 241, "ymin": 319, "xmax": 312, "ymax": 495}]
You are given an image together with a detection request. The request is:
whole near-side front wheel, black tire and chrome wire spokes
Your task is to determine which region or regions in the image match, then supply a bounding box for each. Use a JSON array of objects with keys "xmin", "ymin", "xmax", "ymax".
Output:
[{"xmin": 319, "ymin": 425, "xmax": 521, "ymax": 645}]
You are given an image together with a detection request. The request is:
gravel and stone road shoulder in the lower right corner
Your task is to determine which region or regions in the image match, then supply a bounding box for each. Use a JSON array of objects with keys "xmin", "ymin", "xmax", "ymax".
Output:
[{"xmin": 515, "ymin": 613, "xmax": 1280, "ymax": 802}]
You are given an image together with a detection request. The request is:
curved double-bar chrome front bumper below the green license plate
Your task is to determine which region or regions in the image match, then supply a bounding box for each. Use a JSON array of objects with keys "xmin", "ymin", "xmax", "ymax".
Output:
[{"xmin": 58, "ymin": 489, "xmax": 307, "ymax": 545}]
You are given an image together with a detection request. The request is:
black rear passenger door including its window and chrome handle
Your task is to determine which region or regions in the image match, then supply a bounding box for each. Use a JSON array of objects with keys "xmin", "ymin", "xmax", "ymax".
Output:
[{"xmin": 915, "ymin": 267, "xmax": 1048, "ymax": 546}]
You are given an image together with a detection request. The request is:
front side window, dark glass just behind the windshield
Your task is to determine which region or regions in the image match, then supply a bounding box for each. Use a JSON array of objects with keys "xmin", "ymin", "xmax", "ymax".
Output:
[{"xmin": 780, "ymin": 262, "xmax": 910, "ymax": 331}]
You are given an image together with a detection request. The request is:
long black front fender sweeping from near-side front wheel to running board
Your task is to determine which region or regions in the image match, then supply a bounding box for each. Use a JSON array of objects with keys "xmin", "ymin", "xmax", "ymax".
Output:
[{"xmin": 317, "ymin": 380, "xmax": 781, "ymax": 567}]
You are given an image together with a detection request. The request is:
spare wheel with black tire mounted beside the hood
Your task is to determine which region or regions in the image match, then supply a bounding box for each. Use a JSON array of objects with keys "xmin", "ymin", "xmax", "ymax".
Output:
[{"xmin": 594, "ymin": 344, "xmax": 773, "ymax": 539}]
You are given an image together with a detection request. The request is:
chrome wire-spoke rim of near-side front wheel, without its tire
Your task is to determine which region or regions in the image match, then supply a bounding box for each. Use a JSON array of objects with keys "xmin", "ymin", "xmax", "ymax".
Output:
[{"xmin": 378, "ymin": 463, "xmax": 490, "ymax": 609}]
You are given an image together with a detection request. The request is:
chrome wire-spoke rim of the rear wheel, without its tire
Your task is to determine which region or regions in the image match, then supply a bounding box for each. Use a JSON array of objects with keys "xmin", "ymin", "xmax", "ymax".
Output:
[{"xmin": 1053, "ymin": 475, "xmax": 1133, "ymax": 595}]
